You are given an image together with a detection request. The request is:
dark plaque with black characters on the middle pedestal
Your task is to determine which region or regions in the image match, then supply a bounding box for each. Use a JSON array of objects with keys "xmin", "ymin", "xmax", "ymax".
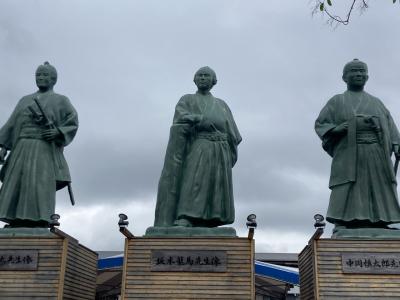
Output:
[{"xmin": 151, "ymin": 250, "xmax": 227, "ymax": 272}]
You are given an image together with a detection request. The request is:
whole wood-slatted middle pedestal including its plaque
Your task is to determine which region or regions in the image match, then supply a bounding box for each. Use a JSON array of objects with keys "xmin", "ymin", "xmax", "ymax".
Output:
[{"xmin": 122, "ymin": 237, "xmax": 255, "ymax": 300}]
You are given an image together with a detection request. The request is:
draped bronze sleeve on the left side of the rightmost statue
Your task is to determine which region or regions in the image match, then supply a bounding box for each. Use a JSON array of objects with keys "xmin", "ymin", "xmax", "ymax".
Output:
[{"xmin": 315, "ymin": 98, "xmax": 338, "ymax": 156}]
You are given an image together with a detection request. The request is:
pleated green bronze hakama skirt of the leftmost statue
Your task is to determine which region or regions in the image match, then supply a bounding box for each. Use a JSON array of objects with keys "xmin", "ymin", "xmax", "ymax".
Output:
[{"xmin": 0, "ymin": 139, "xmax": 56, "ymax": 222}]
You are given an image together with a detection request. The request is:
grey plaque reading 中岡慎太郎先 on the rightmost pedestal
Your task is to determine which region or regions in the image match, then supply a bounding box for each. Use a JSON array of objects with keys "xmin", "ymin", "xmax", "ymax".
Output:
[{"xmin": 342, "ymin": 253, "xmax": 400, "ymax": 274}]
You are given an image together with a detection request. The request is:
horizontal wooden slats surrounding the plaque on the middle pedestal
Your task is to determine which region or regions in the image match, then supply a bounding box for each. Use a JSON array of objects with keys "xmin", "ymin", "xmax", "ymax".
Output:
[{"xmin": 122, "ymin": 238, "xmax": 254, "ymax": 300}]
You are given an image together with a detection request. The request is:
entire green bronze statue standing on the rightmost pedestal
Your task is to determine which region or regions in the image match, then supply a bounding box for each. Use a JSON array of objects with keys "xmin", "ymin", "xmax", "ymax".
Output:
[{"xmin": 315, "ymin": 59, "xmax": 400, "ymax": 237}]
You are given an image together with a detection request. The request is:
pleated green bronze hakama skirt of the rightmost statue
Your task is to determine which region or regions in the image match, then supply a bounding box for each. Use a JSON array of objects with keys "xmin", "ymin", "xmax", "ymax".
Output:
[{"xmin": 327, "ymin": 143, "xmax": 400, "ymax": 224}]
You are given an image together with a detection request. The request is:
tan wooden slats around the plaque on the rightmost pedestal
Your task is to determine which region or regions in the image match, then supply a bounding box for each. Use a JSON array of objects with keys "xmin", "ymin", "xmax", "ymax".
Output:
[{"xmin": 299, "ymin": 239, "xmax": 400, "ymax": 299}]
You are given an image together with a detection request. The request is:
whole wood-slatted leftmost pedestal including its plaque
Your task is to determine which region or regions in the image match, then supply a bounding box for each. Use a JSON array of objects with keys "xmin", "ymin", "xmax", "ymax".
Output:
[{"xmin": 0, "ymin": 229, "xmax": 97, "ymax": 300}]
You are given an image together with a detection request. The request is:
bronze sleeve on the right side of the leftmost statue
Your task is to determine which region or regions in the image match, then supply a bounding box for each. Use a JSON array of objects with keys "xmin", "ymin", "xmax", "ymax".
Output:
[{"xmin": 57, "ymin": 97, "xmax": 79, "ymax": 146}]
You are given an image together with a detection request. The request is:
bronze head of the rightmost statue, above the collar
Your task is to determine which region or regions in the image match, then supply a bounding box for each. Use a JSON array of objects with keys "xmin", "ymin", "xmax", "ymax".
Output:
[{"xmin": 342, "ymin": 58, "xmax": 368, "ymax": 89}]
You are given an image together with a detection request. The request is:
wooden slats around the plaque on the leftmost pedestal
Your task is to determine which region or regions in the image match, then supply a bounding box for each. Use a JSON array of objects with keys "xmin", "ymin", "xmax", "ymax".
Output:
[{"xmin": 0, "ymin": 235, "xmax": 97, "ymax": 300}]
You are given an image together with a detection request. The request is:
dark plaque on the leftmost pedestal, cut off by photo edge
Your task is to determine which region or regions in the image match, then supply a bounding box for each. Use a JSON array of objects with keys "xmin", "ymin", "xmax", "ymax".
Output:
[{"xmin": 0, "ymin": 250, "xmax": 39, "ymax": 271}]
